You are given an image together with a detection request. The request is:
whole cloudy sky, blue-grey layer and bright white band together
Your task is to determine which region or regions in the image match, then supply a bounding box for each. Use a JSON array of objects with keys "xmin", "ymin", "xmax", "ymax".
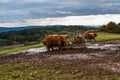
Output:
[{"xmin": 0, "ymin": 0, "xmax": 120, "ymax": 27}]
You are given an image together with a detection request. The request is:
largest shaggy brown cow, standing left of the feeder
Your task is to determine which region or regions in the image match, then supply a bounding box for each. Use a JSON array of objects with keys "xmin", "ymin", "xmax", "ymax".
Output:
[{"xmin": 45, "ymin": 35, "xmax": 67, "ymax": 51}]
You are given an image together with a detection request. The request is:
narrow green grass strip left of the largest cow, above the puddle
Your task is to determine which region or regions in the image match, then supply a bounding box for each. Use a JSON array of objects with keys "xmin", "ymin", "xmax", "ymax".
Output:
[{"xmin": 0, "ymin": 44, "xmax": 43, "ymax": 54}]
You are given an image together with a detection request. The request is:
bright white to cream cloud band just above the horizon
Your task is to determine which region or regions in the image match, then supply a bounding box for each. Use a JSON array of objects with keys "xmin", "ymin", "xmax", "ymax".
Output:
[{"xmin": 0, "ymin": 14, "xmax": 120, "ymax": 27}]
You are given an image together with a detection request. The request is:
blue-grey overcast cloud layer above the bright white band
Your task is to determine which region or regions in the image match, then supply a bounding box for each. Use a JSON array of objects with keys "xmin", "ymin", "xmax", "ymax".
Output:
[{"xmin": 0, "ymin": 0, "xmax": 120, "ymax": 26}]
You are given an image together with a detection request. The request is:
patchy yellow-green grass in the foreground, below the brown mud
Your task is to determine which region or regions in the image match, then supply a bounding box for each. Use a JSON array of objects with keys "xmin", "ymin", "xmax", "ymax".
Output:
[{"xmin": 0, "ymin": 61, "xmax": 120, "ymax": 80}]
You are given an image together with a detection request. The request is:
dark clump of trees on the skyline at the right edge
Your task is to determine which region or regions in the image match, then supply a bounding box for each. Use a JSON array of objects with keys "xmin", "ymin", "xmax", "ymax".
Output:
[{"xmin": 100, "ymin": 22, "xmax": 120, "ymax": 34}]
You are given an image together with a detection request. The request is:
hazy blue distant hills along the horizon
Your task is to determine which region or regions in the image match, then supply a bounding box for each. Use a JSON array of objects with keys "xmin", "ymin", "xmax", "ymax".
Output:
[{"xmin": 0, "ymin": 25, "xmax": 100, "ymax": 33}]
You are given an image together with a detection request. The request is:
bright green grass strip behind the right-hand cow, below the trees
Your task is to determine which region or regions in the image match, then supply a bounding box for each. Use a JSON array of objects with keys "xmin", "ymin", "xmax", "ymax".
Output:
[{"xmin": 96, "ymin": 33, "xmax": 120, "ymax": 41}]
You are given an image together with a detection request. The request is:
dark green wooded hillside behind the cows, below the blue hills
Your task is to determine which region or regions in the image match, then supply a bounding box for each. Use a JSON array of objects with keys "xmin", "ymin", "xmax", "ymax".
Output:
[{"xmin": 0, "ymin": 26, "xmax": 93, "ymax": 46}]
